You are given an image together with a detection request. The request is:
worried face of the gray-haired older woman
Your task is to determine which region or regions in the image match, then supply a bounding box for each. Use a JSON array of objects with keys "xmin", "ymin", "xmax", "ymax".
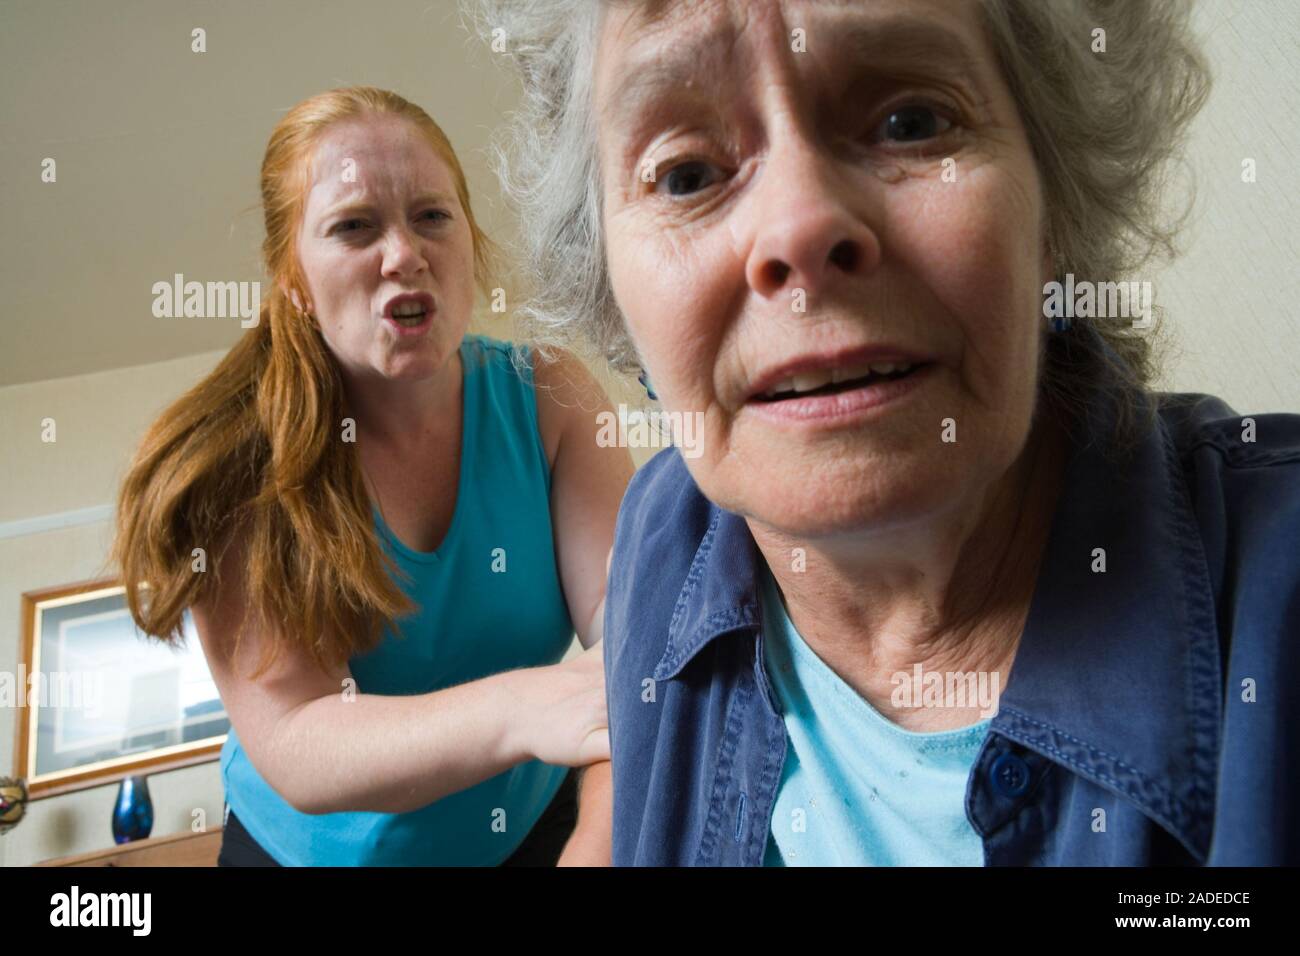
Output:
[{"xmin": 595, "ymin": 0, "xmax": 1050, "ymax": 535}]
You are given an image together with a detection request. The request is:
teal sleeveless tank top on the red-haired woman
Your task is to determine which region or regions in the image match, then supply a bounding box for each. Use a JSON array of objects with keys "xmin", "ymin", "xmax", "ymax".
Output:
[{"xmin": 221, "ymin": 334, "xmax": 573, "ymax": 866}]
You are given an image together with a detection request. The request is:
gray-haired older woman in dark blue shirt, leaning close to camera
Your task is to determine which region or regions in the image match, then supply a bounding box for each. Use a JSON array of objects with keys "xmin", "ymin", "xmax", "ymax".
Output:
[{"xmin": 480, "ymin": 0, "xmax": 1300, "ymax": 866}]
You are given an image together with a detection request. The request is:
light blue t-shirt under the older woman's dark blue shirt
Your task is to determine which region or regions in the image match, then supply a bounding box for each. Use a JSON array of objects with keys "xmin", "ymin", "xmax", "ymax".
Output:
[{"xmin": 759, "ymin": 566, "xmax": 991, "ymax": 866}]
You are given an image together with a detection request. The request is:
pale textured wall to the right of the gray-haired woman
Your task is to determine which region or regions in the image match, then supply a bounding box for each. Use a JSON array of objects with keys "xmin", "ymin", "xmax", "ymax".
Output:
[{"xmin": 1156, "ymin": 0, "xmax": 1300, "ymax": 415}]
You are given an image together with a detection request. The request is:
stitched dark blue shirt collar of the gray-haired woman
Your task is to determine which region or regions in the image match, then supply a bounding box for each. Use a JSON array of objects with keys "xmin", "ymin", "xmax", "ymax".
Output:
[{"xmin": 654, "ymin": 385, "xmax": 1222, "ymax": 861}]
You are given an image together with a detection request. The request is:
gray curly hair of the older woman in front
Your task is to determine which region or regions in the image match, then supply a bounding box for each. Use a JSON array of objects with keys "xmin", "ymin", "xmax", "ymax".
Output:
[{"xmin": 462, "ymin": 0, "xmax": 1210, "ymax": 441}]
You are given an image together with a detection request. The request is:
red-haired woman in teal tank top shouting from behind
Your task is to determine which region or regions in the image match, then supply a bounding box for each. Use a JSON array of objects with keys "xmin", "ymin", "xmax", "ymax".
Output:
[{"xmin": 116, "ymin": 87, "xmax": 632, "ymax": 865}]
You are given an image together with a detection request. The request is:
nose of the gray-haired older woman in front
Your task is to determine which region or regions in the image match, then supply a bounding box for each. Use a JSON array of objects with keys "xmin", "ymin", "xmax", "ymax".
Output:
[{"xmin": 745, "ymin": 133, "xmax": 880, "ymax": 299}]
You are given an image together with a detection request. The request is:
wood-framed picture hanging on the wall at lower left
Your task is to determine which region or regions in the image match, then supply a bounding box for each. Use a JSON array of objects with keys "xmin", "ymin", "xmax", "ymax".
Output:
[{"xmin": 16, "ymin": 580, "xmax": 230, "ymax": 800}]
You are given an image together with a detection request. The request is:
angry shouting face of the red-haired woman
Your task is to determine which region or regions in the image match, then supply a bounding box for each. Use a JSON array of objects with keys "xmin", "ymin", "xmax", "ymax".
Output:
[{"xmin": 298, "ymin": 116, "xmax": 475, "ymax": 380}]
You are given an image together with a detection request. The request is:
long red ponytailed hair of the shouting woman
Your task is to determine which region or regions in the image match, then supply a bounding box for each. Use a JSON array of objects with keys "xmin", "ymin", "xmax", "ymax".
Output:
[{"xmin": 112, "ymin": 87, "xmax": 494, "ymax": 672}]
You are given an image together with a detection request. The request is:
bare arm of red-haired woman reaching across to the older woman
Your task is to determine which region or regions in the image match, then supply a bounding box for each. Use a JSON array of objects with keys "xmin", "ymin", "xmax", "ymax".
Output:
[{"xmin": 192, "ymin": 528, "xmax": 610, "ymax": 813}]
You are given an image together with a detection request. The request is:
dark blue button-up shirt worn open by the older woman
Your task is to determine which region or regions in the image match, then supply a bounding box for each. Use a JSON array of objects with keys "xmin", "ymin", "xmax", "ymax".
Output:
[{"xmin": 605, "ymin": 395, "xmax": 1300, "ymax": 866}]
